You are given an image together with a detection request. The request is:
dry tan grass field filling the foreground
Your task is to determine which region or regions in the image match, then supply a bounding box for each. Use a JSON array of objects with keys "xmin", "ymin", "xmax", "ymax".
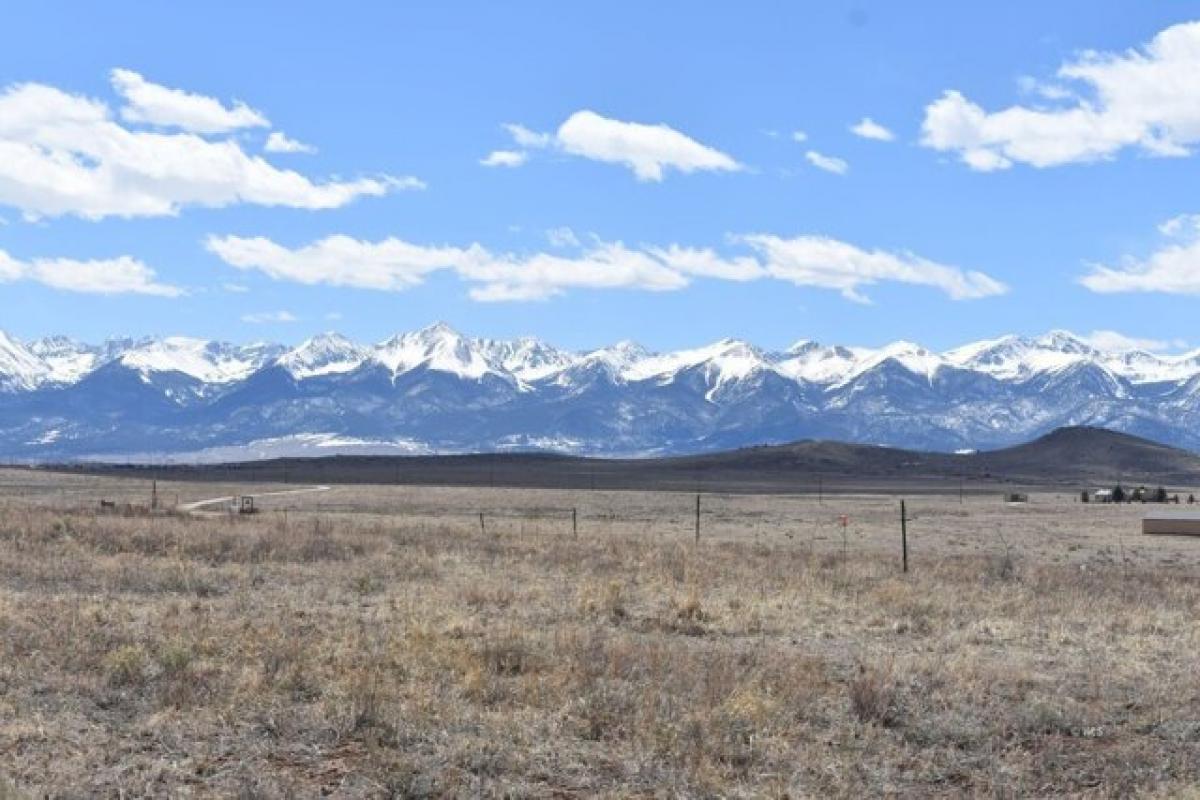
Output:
[{"xmin": 0, "ymin": 471, "xmax": 1200, "ymax": 798}]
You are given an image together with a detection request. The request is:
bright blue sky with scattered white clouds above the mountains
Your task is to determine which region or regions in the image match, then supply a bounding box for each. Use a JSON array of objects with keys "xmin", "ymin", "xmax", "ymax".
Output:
[{"xmin": 0, "ymin": 2, "xmax": 1200, "ymax": 349}]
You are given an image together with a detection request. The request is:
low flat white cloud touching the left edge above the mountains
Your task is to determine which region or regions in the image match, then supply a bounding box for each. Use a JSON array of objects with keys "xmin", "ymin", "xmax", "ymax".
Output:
[{"xmin": 0, "ymin": 251, "xmax": 184, "ymax": 297}]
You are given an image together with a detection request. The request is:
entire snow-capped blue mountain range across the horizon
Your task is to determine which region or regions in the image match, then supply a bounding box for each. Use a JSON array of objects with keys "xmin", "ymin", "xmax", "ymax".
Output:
[{"xmin": 0, "ymin": 324, "xmax": 1200, "ymax": 459}]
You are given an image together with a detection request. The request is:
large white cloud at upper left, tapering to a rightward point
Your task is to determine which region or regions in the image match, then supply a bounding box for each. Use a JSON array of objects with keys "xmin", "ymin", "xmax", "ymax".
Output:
[{"xmin": 0, "ymin": 73, "xmax": 422, "ymax": 219}]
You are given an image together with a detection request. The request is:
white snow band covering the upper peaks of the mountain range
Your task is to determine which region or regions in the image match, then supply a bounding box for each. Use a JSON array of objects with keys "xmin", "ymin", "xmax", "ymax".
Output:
[{"xmin": 0, "ymin": 323, "xmax": 1200, "ymax": 391}]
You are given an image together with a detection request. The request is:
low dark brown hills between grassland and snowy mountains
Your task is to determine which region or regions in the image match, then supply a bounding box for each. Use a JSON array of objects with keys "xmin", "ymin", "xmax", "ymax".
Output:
[{"xmin": 63, "ymin": 427, "xmax": 1200, "ymax": 492}]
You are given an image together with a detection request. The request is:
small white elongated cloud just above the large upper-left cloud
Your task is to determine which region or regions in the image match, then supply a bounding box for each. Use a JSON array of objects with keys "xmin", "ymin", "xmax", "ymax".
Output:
[{"xmin": 109, "ymin": 70, "xmax": 271, "ymax": 133}]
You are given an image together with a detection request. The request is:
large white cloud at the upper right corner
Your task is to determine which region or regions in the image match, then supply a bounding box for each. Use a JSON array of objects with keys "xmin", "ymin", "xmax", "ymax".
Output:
[{"xmin": 922, "ymin": 23, "xmax": 1200, "ymax": 172}]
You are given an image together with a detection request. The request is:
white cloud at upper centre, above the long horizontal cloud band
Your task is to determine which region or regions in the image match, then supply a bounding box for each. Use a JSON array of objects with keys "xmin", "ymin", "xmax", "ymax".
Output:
[{"xmin": 484, "ymin": 109, "xmax": 743, "ymax": 182}]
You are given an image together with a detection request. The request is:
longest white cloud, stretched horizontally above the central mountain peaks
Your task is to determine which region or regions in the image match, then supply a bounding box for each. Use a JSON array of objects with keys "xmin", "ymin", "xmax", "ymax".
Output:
[{"xmin": 206, "ymin": 234, "xmax": 1007, "ymax": 302}]
